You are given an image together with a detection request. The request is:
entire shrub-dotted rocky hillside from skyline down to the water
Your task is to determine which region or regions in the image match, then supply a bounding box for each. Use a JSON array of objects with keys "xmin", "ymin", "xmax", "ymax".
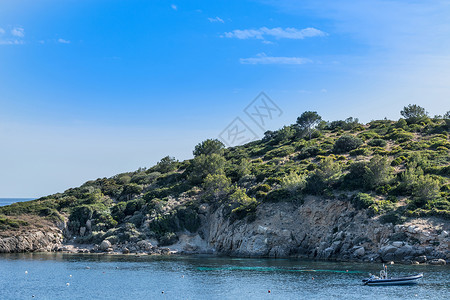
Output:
[{"xmin": 0, "ymin": 105, "xmax": 450, "ymax": 259}]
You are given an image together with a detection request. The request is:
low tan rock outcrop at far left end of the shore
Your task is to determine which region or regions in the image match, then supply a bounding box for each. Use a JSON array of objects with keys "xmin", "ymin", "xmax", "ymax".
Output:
[{"xmin": 0, "ymin": 231, "xmax": 63, "ymax": 253}]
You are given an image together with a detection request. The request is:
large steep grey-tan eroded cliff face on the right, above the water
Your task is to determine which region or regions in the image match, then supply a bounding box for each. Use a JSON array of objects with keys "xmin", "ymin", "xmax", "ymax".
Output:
[{"xmin": 202, "ymin": 197, "xmax": 449, "ymax": 262}]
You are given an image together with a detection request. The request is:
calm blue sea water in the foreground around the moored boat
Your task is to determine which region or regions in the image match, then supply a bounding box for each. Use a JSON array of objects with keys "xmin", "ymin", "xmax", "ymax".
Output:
[{"xmin": 0, "ymin": 254, "xmax": 450, "ymax": 299}]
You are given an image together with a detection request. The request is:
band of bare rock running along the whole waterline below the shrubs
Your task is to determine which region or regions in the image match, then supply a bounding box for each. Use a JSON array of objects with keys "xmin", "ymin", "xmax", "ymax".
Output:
[{"xmin": 0, "ymin": 197, "xmax": 450, "ymax": 265}]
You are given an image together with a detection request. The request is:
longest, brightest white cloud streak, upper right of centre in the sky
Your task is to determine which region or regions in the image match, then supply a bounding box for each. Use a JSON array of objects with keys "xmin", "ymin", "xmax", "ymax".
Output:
[{"xmin": 225, "ymin": 27, "xmax": 327, "ymax": 40}]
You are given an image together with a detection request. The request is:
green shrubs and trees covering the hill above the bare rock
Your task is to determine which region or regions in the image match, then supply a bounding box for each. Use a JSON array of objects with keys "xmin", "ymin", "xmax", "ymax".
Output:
[{"xmin": 0, "ymin": 105, "xmax": 450, "ymax": 244}]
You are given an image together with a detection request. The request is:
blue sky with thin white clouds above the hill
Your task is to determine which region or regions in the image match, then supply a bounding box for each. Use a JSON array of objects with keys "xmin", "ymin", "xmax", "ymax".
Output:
[{"xmin": 0, "ymin": 0, "xmax": 450, "ymax": 197}]
